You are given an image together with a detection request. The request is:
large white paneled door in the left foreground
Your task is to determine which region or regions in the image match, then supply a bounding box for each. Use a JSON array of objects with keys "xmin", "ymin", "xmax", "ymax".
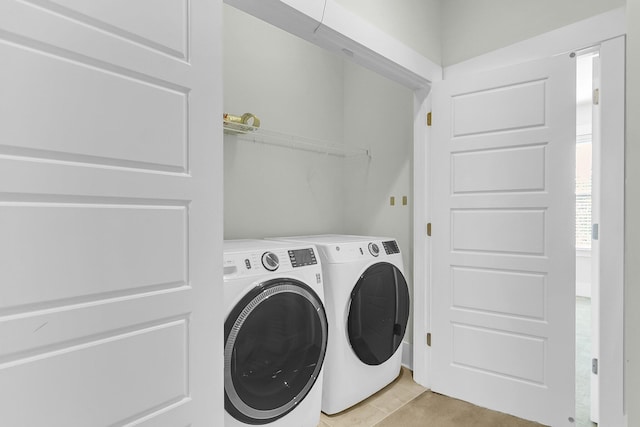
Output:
[{"xmin": 0, "ymin": 0, "xmax": 224, "ymax": 427}]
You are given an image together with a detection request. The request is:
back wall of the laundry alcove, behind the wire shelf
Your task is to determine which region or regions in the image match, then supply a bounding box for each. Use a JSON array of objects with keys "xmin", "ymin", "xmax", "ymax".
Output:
[{"xmin": 223, "ymin": 5, "xmax": 344, "ymax": 239}]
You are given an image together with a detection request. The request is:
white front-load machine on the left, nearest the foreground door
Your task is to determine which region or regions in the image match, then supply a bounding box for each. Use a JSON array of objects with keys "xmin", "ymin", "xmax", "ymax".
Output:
[{"xmin": 223, "ymin": 240, "xmax": 328, "ymax": 427}]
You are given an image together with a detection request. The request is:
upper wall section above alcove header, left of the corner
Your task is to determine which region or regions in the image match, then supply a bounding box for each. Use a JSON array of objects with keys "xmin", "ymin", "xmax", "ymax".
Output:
[{"xmin": 336, "ymin": 0, "xmax": 442, "ymax": 64}]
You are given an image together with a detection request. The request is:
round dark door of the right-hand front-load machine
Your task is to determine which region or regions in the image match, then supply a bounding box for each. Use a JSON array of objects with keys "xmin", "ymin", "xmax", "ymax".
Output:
[{"xmin": 347, "ymin": 262, "xmax": 409, "ymax": 365}]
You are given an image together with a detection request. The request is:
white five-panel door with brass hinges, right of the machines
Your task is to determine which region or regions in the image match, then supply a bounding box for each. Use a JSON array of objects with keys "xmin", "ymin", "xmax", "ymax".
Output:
[{"xmin": 431, "ymin": 54, "xmax": 576, "ymax": 426}]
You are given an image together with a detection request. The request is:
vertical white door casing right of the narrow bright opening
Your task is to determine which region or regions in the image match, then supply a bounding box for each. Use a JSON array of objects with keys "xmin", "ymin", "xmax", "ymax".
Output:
[{"xmin": 598, "ymin": 37, "xmax": 626, "ymax": 427}]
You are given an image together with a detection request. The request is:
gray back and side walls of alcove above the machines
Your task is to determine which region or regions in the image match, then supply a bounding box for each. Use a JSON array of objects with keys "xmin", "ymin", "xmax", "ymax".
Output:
[{"xmin": 223, "ymin": 5, "xmax": 413, "ymax": 339}]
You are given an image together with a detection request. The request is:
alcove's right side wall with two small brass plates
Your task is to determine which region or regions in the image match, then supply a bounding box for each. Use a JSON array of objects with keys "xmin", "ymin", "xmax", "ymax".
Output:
[{"xmin": 344, "ymin": 62, "xmax": 413, "ymax": 342}]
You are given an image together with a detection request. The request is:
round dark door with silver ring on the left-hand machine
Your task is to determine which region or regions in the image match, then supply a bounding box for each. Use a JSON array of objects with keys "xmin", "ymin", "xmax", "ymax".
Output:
[{"xmin": 224, "ymin": 279, "xmax": 327, "ymax": 425}]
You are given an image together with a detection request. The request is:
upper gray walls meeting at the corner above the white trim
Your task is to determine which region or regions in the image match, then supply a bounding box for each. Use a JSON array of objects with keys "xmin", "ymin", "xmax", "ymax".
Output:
[{"xmin": 336, "ymin": 0, "xmax": 625, "ymax": 67}]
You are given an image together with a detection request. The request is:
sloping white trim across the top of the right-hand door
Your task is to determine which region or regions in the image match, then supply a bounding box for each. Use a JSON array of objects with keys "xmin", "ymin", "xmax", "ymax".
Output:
[{"xmin": 443, "ymin": 7, "xmax": 627, "ymax": 79}]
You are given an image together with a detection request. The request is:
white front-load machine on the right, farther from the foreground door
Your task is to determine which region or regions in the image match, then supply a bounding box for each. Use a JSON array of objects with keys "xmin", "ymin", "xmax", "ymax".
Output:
[{"xmin": 270, "ymin": 235, "xmax": 409, "ymax": 414}]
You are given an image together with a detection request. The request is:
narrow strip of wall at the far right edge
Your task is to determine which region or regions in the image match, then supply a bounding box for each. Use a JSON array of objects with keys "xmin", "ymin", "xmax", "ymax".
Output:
[{"xmin": 625, "ymin": 0, "xmax": 640, "ymax": 427}]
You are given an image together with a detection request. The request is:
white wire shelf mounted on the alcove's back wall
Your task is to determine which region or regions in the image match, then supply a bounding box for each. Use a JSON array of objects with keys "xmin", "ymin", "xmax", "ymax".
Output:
[{"xmin": 224, "ymin": 121, "xmax": 371, "ymax": 157}]
